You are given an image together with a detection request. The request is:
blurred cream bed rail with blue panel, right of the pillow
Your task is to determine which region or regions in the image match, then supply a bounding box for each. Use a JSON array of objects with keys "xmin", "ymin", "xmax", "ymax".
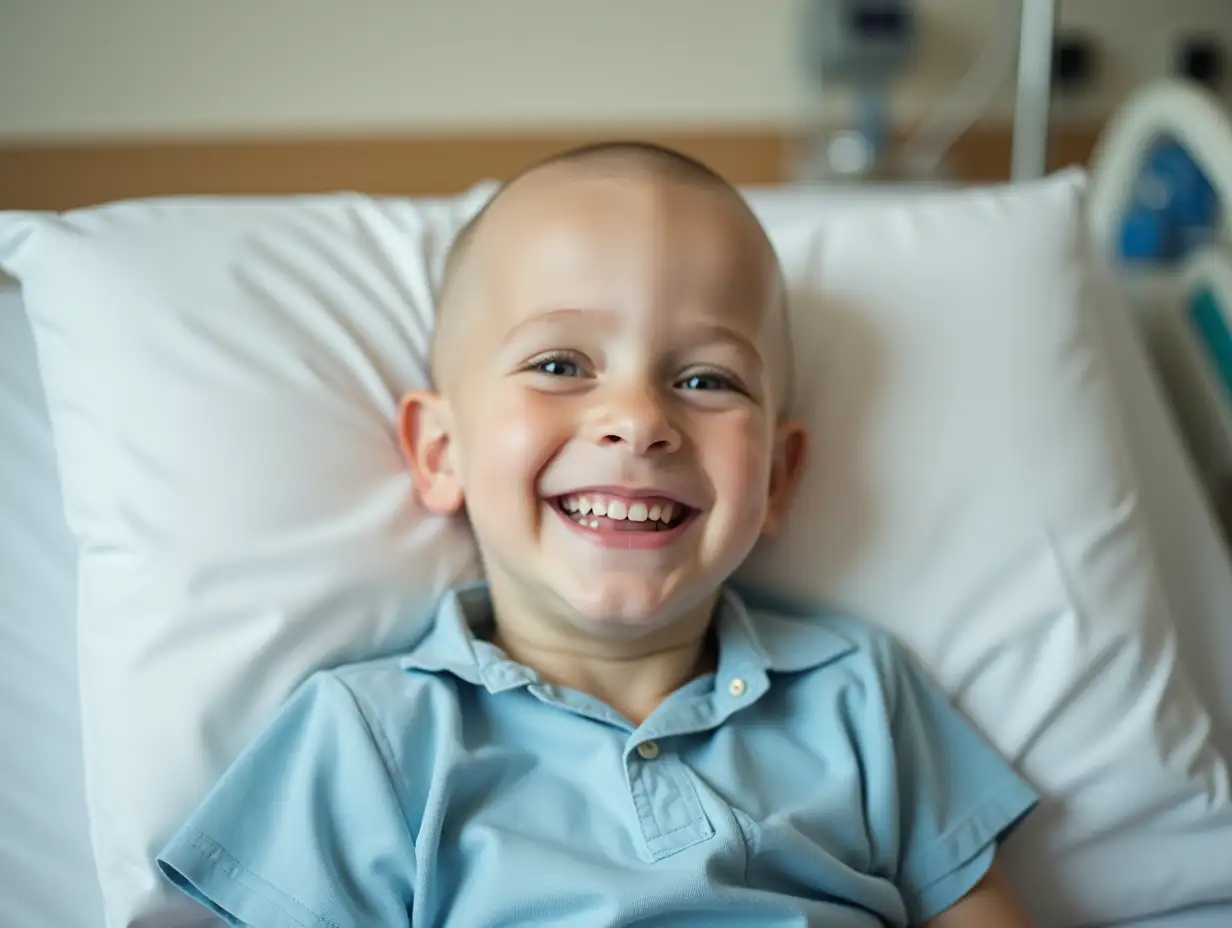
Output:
[{"xmin": 1090, "ymin": 79, "xmax": 1232, "ymax": 527}]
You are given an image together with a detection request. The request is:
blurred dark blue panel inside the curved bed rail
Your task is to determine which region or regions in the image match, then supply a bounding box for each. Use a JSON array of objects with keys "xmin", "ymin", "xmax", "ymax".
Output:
[{"xmin": 1117, "ymin": 138, "xmax": 1221, "ymax": 265}]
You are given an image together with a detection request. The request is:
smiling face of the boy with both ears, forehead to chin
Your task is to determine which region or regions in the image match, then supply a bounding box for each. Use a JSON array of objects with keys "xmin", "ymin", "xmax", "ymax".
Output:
[{"xmin": 404, "ymin": 158, "xmax": 802, "ymax": 641}]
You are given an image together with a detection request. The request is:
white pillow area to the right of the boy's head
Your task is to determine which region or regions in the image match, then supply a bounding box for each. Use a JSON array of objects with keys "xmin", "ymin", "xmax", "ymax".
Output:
[{"xmin": 743, "ymin": 171, "xmax": 1232, "ymax": 926}]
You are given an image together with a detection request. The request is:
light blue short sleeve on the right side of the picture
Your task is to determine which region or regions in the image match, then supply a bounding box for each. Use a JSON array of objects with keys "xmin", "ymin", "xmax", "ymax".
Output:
[{"xmin": 887, "ymin": 651, "xmax": 1037, "ymax": 923}]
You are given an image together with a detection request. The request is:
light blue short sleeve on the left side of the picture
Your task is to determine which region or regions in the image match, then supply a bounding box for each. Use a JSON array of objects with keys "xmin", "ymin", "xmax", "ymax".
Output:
[{"xmin": 158, "ymin": 673, "xmax": 415, "ymax": 928}]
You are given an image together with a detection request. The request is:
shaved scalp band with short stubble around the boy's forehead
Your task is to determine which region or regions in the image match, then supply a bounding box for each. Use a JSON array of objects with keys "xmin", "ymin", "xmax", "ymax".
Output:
[{"xmin": 431, "ymin": 142, "xmax": 791, "ymax": 413}]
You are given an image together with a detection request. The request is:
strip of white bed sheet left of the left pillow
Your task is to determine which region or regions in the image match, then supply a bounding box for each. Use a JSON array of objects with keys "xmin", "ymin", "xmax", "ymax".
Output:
[{"xmin": 0, "ymin": 275, "xmax": 102, "ymax": 928}]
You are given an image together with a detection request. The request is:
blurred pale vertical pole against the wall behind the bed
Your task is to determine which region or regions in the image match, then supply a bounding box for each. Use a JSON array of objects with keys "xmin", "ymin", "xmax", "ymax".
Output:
[{"xmin": 1013, "ymin": 0, "xmax": 1057, "ymax": 181}]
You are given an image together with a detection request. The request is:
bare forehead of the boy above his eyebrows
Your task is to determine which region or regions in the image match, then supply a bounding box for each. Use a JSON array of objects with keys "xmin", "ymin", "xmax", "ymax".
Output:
[{"xmin": 473, "ymin": 170, "xmax": 777, "ymax": 334}]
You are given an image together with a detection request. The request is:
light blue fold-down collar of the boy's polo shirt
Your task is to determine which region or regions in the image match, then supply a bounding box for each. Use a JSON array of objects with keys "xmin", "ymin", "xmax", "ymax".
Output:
[{"xmin": 402, "ymin": 582, "xmax": 856, "ymax": 693}]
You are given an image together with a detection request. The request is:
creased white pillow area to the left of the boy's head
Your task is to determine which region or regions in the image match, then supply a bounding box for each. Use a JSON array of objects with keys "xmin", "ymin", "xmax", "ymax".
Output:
[{"xmin": 0, "ymin": 190, "xmax": 489, "ymax": 926}]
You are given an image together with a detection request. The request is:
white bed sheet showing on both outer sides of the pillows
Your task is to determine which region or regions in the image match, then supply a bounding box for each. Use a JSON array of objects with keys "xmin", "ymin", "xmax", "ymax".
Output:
[{"xmin": 0, "ymin": 220, "xmax": 1232, "ymax": 928}]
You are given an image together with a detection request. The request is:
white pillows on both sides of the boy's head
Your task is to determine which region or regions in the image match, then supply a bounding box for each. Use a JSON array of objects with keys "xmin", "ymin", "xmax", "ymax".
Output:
[{"xmin": 0, "ymin": 170, "xmax": 1232, "ymax": 926}]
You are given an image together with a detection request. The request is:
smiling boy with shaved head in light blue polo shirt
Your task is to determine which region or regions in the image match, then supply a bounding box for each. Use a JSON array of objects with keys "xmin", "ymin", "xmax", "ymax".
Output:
[{"xmin": 159, "ymin": 144, "xmax": 1035, "ymax": 928}]
